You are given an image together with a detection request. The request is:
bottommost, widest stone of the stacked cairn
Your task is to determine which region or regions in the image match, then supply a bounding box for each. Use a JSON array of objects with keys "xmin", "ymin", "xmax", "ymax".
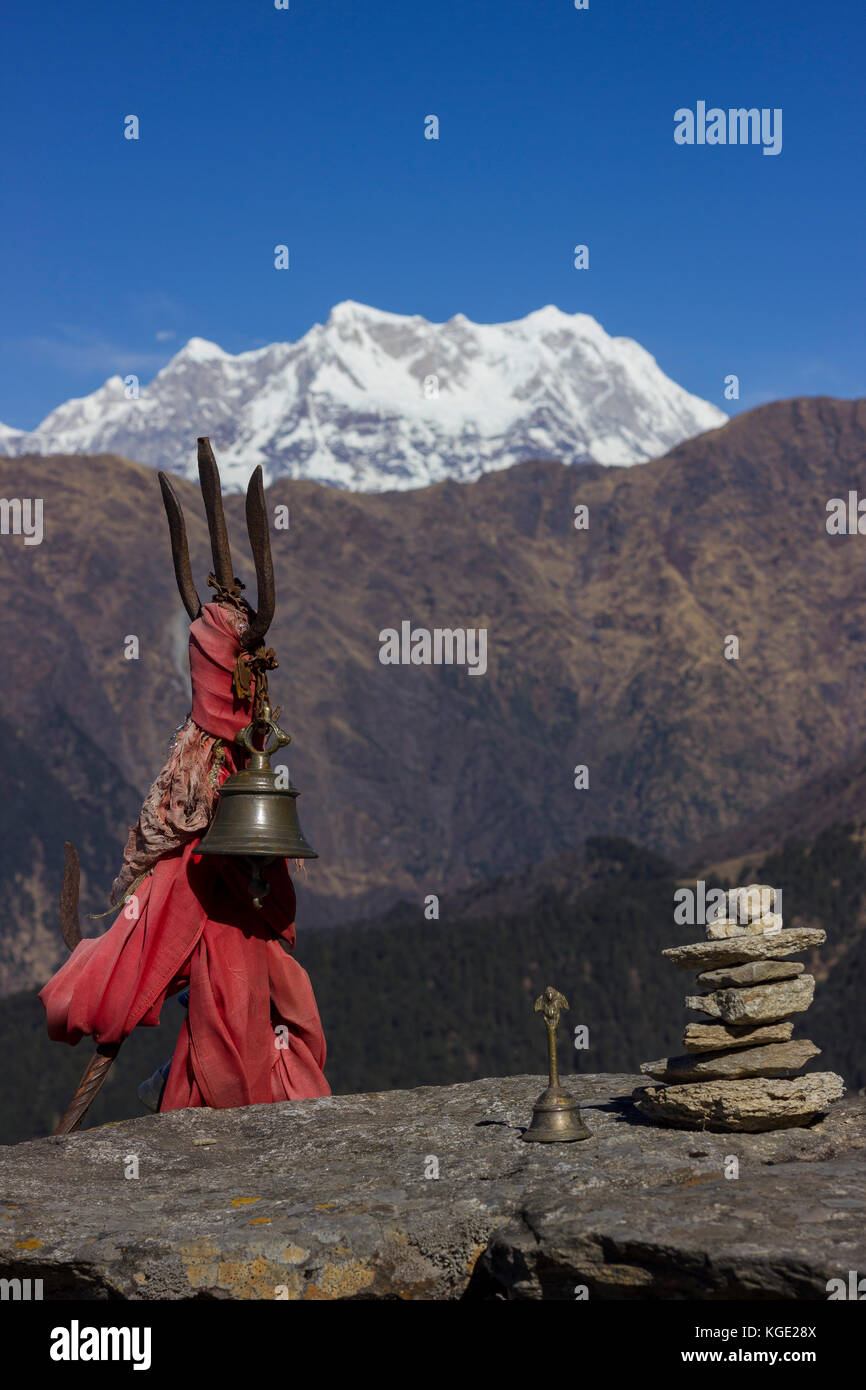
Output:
[{"xmin": 634, "ymin": 1072, "xmax": 845, "ymax": 1134}]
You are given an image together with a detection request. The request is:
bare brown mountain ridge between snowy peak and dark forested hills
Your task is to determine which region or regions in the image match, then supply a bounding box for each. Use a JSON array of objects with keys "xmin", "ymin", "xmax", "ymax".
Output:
[{"xmin": 0, "ymin": 399, "xmax": 866, "ymax": 988}]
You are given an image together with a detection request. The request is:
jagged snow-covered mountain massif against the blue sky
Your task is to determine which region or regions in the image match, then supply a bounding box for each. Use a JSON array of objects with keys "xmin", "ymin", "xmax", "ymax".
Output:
[{"xmin": 0, "ymin": 299, "xmax": 727, "ymax": 491}]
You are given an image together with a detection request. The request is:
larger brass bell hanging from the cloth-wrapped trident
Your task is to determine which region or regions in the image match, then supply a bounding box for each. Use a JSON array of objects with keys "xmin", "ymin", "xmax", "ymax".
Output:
[{"xmin": 197, "ymin": 705, "xmax": 318, "ymax": 908}]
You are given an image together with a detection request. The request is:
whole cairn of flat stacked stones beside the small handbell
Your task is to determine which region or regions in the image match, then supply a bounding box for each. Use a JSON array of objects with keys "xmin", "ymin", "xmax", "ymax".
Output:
[{"xmin": 634, "ymin": 884, "xmax": 845, "ymax": 1131}]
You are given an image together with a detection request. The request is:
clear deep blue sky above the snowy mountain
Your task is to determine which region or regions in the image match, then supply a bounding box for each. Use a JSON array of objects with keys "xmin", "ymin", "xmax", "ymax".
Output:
[{"xmin": 0, "ymin": 0, "xmax": 866, "ymax": 428}]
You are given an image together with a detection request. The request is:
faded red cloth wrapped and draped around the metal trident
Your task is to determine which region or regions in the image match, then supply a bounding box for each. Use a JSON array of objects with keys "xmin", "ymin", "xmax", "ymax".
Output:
[{"xmin": 39, "ymin": 603, "xmax": 331, "ymax": 1111}]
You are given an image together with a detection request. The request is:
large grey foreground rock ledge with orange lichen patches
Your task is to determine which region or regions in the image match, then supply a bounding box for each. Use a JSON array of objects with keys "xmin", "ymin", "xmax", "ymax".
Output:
[{"xmin": 0, "ymin": 1074, "xmax": 866, "ymax": 1304}]
